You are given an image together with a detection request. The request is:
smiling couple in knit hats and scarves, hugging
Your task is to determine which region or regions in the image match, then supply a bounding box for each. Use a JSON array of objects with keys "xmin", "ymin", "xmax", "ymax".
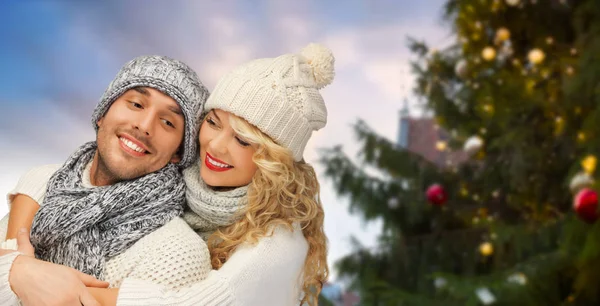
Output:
[{"xmin": 0, "ymin": 44, "xmax": 334, "ymax": 306}]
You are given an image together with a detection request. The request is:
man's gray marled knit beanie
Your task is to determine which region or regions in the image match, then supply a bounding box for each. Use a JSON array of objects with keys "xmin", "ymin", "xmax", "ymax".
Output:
[{"xmin": 92, "ymin": 55, "xmax": 208, "ymax": 167}]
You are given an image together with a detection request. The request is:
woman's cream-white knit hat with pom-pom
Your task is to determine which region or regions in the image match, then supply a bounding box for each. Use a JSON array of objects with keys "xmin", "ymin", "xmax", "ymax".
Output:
[{"xmin": 204, "ymin": 44, "xmax": 335, "ymax": 161}]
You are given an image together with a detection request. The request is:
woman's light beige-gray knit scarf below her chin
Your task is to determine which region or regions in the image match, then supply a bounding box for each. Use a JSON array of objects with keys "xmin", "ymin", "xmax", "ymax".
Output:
[{"xmin": 183, "ymin": 159, "xmax": 248, "ymax": 240}]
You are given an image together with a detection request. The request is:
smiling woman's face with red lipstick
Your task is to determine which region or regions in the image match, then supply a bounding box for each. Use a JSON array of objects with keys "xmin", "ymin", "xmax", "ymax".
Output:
[{"xmin": 200, "ymin": 109, "xmax": 257, "ymax": 187}]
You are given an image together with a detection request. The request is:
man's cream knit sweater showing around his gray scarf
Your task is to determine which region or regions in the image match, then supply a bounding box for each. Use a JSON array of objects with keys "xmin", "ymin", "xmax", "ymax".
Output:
[{"xmin": 0, "ymin": 164, "xmax": 211, "ymax": 289}]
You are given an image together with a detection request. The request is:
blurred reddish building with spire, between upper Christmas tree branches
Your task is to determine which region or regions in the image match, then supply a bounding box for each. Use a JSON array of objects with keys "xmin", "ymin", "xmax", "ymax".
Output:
[{"xmin": 396, "ymin": 100, "xmax": 468, "ymax": 167}]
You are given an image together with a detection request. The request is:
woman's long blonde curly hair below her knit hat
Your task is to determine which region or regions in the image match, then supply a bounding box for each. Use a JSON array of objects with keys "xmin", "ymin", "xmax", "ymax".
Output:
[{"xmin": 208, "ymin": 114, "xmax": 329, "ymax": 306}]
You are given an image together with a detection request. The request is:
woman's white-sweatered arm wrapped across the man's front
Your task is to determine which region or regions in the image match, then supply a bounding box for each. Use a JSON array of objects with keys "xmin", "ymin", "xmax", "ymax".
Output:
[{"xmin": 110, "ymin": 228, "xmax": 308, "ymax": 306}]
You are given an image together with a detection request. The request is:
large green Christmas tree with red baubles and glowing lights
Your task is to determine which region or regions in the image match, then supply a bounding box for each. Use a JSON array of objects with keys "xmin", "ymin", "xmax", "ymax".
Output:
[{"xmin": 321, "ymin": 0, "xmax": 600, "ymax": 305}]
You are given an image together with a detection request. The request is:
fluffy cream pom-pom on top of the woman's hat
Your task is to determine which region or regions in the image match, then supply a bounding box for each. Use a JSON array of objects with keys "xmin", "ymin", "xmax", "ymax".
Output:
[{"xmin": 301, "ymin": 43, "xmax": 335, "ymax": 89}]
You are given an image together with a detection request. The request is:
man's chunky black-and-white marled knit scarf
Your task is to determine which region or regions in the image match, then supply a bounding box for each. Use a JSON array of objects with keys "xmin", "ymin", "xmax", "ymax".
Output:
[{"xmin": 31, "ymin": 142, "xmax": 185, "ymax": 279}]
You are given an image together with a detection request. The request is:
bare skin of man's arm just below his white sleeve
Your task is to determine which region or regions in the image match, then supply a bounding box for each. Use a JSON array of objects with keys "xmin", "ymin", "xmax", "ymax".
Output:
[{"xmin": 5, "ymin": 194, "xmax": 40, "ymax": 240}]
